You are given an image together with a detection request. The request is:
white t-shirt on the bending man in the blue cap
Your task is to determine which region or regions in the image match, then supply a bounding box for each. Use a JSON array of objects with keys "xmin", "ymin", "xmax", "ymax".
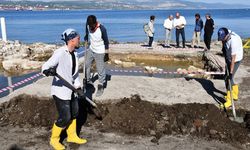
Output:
[{"xmin": 226, "ymin": 30, "xmax": 243, "ymax": 62}]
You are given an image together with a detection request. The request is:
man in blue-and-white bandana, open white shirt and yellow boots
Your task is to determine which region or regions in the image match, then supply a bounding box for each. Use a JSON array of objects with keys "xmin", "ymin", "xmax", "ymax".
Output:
[{"xmin": 42, "ymin": 29, "xmax": 87, "ymax": 150}]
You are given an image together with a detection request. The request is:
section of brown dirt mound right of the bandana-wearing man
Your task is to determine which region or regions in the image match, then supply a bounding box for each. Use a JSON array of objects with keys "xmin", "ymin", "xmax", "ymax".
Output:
[{"xmin": 90, "ymin": 96, "xmax": 250, "ymax": 143}]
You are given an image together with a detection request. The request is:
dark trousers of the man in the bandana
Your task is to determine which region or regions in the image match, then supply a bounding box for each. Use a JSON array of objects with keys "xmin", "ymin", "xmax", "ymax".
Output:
[{"xmin": 53, "ymin": 94, "xmax": 79, "ymax": 128}]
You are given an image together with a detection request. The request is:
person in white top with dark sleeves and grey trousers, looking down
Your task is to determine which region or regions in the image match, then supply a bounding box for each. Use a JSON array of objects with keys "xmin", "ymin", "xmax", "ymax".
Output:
[{"xmin": 84, "ymin": 15, "xmax": 109, "ymax": 97}]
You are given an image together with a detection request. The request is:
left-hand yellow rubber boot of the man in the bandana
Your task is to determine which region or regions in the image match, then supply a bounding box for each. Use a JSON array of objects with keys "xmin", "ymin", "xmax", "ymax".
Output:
[{"xmin": 50, "ymin": 123, "xmax": 65, "ymax": 150}]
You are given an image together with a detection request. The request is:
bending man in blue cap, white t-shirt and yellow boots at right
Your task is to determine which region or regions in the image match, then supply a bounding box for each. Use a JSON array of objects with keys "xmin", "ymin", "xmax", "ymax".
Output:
[{"xmin": 218, "ymin": 28, "xmax": 243, "ymax": 108}]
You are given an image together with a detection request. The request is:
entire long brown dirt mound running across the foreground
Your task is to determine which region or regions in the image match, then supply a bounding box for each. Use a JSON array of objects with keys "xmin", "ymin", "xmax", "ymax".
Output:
[{"xmin": 0, "ymin": 95, "xmax": 250, "ymax": 144}]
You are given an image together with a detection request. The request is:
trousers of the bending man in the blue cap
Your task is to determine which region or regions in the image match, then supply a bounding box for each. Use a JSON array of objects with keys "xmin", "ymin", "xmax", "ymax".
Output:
[{"xmin": 225, "ymin": 61, "xmax": 241, "ymax": 91}]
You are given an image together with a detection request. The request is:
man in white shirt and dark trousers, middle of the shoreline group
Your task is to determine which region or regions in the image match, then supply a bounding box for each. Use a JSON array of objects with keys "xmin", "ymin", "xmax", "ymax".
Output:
[{"xmin": 174, "ymin": 12, "xmax": 187, "ymax": 48}]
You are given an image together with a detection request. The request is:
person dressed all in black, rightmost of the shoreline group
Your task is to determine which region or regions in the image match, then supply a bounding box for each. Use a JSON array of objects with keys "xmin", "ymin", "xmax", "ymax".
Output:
[{"xmin": 204, "ymin": 14, "xmax": 214, "ymax": 50}]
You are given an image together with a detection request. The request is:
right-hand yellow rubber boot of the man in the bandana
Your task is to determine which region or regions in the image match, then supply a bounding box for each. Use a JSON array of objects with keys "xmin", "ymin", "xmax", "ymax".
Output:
[{"xmin": 67, "ymin": 119, "xmax": 87, "ymax": 144}]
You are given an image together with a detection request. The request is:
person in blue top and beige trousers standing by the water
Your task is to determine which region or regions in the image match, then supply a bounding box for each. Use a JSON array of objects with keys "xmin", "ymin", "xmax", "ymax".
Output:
[{"xmin": 191, "ymin": 13, "xmax": 203, "ymax": 48}]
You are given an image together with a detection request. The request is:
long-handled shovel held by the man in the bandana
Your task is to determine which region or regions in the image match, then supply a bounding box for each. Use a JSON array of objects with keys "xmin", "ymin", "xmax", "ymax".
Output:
[{"xmin": 55, "ymin": 73, "xmax": 102, "ymax": 120}]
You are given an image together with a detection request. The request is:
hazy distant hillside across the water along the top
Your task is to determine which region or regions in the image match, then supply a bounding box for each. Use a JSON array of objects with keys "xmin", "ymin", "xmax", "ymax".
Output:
[{"xmin": 0, "ymin": 0, "xmax": 250, "ymax": 9}]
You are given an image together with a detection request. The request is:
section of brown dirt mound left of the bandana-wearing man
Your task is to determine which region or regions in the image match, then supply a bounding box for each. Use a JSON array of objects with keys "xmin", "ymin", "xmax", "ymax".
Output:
[{"xmin": 0, "ymin": 95, "xmax": 56, "ymax": 127}]
